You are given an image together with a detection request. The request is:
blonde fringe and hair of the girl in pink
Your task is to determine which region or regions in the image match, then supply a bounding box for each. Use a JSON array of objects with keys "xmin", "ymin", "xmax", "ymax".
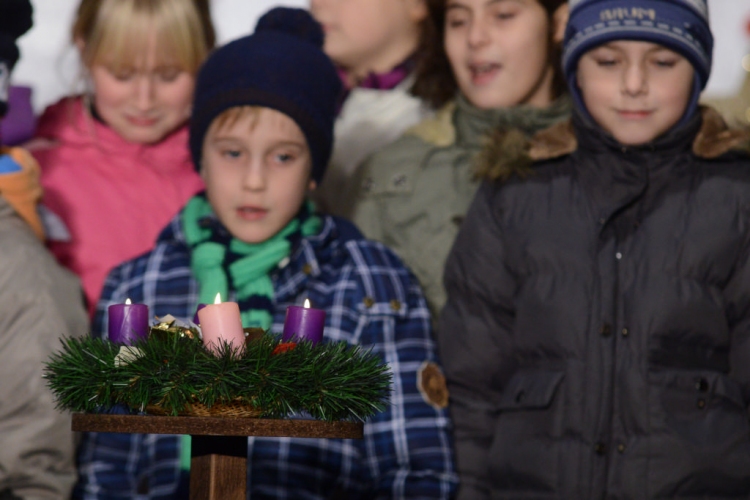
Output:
[{"xmin": 72, "ymin": 0, "xmax": 216, "ymax": 74}]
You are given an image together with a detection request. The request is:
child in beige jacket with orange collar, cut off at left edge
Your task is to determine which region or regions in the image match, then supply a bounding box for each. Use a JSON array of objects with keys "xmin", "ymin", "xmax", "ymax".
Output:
[{"xmin": 0, "ymin": 0, "xmax": 87, "ymax": 500}]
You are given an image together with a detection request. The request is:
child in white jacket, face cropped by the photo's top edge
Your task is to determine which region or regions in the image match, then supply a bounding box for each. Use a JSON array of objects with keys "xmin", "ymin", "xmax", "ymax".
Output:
[{"xmin": 310, "ymin": 0, "xmax": 434, "ymax": 216}]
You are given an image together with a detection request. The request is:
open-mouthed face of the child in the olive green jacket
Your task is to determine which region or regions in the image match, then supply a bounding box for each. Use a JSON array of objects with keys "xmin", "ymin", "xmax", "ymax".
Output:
[{"xmin": 444, "ymin": 0, "xmax": 567, "ymax": 109}]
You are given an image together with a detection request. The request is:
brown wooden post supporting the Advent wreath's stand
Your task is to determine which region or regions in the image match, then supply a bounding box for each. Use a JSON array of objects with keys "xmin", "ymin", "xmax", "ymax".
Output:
[{"xmin": 190, "ymin": 436, "xmax": 247, "ymax": 500}]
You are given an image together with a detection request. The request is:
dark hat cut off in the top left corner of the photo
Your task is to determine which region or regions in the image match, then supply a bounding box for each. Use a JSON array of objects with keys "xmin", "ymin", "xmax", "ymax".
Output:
[{"xmin": 0, "ymin": 0, "xmax": 33, "ymax": 117}]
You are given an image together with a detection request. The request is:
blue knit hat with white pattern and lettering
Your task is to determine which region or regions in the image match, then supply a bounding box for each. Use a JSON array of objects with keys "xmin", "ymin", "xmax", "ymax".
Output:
[{"xmin": 563, "ymin": 0, "xmax": 714, "ymax": 121}]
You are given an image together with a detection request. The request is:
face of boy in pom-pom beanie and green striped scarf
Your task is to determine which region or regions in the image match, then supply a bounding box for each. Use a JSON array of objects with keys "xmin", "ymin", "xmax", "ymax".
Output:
[{"xmin": 201, "ymin": 108, "xmax": 315, "ymax": 243}]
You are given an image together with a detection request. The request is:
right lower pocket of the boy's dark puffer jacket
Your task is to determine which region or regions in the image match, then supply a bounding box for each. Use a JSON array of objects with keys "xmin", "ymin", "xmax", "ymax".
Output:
[{"xmin": 648, "ymin": 370, "xmax": 750, "ymax": 498}]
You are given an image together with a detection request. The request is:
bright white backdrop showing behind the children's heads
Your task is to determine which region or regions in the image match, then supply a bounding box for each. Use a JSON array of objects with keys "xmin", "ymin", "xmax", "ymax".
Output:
[{"xmin": 10, "ymin": 0, "xmax": 750, "ymax": 112}]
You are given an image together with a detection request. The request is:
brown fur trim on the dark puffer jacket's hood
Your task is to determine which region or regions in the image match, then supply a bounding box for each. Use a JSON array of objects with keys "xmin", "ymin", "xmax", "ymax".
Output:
[{"xmin": 476, "ymin": 107, "xmax": 750, "ymax": 181}]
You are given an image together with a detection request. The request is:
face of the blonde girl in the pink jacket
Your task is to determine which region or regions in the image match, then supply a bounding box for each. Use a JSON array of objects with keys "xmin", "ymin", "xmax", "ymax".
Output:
[{"xmin": 89, "ymin": 33, "xmax": 195, "ymax": 144}]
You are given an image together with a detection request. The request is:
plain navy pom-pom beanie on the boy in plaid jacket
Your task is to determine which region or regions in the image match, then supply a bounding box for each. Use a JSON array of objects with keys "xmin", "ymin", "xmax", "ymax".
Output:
[{"xmin": 190, "ymin": 7, "xmax": 342, "ymax": 182}]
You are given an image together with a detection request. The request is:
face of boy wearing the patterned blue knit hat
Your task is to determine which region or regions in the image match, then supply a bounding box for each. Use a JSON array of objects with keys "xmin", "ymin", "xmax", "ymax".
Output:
[{"xmin": 577, "ymin": 40, "xmax": 694, "ymax": 146}]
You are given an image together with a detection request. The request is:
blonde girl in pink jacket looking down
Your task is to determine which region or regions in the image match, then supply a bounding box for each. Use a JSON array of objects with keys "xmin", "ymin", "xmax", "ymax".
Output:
[{"xmin": 30, "ymin": 0, "xmax": 214, "ymax": 313}]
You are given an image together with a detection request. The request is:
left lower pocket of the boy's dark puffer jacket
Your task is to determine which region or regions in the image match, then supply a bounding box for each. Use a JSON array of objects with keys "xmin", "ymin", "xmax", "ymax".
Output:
[{"xmin": 489, "ymin": 370, "xmax": 565, "ymax": 499}]
